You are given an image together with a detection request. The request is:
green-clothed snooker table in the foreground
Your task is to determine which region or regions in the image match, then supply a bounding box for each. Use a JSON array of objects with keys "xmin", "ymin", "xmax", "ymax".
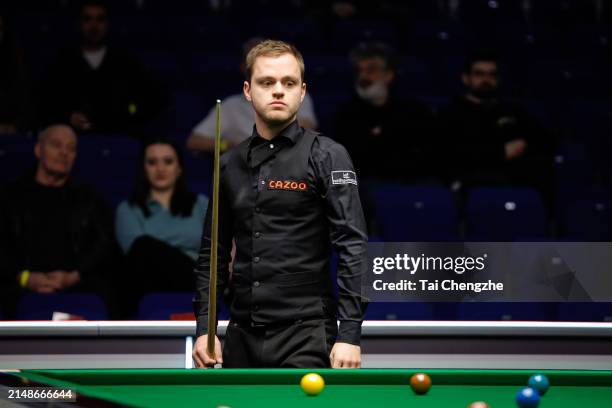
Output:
[{"xmin": 3, "ymin": 369, "xmax": 612, "ymax": 408}]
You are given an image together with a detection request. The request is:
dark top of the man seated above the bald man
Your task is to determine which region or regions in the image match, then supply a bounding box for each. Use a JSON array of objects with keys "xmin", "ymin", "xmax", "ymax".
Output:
[{"xmin": 40, "ymin": 46, "xmax": 166, "ymax": 132}]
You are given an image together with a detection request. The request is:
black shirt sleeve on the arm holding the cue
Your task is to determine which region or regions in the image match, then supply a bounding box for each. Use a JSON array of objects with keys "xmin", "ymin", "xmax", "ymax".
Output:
[{"xmin": 193, "ymin": 164, "xmax": 233, "ymax": 337}]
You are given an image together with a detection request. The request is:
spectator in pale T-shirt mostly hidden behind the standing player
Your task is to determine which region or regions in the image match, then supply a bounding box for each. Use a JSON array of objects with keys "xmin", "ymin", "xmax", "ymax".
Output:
[{"xmin": 187, "ymin": 38, "xmax": 317, "ymax": 152}]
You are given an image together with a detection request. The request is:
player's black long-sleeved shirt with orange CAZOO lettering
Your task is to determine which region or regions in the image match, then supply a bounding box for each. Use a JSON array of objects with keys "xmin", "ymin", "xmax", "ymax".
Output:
[{"xmin": 194, "ymin": 122, "xmax": 367, "ymax": 344}]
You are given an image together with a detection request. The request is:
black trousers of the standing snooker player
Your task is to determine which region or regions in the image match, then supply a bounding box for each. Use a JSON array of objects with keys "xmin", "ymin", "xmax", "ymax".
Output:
[{"xmin": 223, "ymin": 319, "xmax": 338, "ymax": 368}]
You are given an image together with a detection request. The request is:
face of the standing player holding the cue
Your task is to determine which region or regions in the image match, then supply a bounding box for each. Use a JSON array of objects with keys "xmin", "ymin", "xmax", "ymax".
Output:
[{"xmin": 244, "ymin": 54, "xmax": 306, "ymax": 126}]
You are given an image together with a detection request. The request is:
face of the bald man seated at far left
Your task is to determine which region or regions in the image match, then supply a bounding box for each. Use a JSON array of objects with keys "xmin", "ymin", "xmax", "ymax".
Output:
[{"xmin": 35, "ymin": 127, "xmax": 77, "ymax": 177}]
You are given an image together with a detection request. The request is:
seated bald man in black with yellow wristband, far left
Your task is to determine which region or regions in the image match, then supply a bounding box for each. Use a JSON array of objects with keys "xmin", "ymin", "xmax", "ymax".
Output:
[{"xmin": 0, "ymin": 125, "xmax": 112, "ymax": 315}]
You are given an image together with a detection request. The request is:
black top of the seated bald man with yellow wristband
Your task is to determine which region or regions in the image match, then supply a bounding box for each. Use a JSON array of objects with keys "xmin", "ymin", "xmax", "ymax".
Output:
[{"xmin": 0, "ymin": 172, "xmax": 113, "ymax": 291}]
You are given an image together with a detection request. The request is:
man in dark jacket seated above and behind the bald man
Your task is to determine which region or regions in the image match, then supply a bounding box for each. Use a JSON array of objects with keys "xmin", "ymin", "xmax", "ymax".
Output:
[{"xmin": 40, "ymin": 0, "xmax": 166, "ymax": 134}]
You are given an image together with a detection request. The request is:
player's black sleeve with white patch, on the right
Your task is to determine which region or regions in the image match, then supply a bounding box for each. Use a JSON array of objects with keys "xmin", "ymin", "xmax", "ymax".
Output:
[{"xmin": 314, "ymin": 139, "xmax": 368, "ymax": 345}]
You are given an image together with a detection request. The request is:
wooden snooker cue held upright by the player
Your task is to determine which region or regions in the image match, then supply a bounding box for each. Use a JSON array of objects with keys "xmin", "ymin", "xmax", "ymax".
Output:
[{"xmin": 207, "ymin": 99, "xmax": 221, "ymax": 359}]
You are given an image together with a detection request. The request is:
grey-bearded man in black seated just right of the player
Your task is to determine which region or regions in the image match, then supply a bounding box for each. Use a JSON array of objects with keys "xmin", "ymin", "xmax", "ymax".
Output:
[{"xmin": 332, "ymin": 43, "xmax": 432, "ymax": 181}]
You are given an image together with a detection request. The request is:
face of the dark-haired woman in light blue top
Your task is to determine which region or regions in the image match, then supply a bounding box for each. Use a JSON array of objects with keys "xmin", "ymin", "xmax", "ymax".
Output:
[{"xmin": 145, "ymin": 143, "xmax": 181, "ymax": 191}]
